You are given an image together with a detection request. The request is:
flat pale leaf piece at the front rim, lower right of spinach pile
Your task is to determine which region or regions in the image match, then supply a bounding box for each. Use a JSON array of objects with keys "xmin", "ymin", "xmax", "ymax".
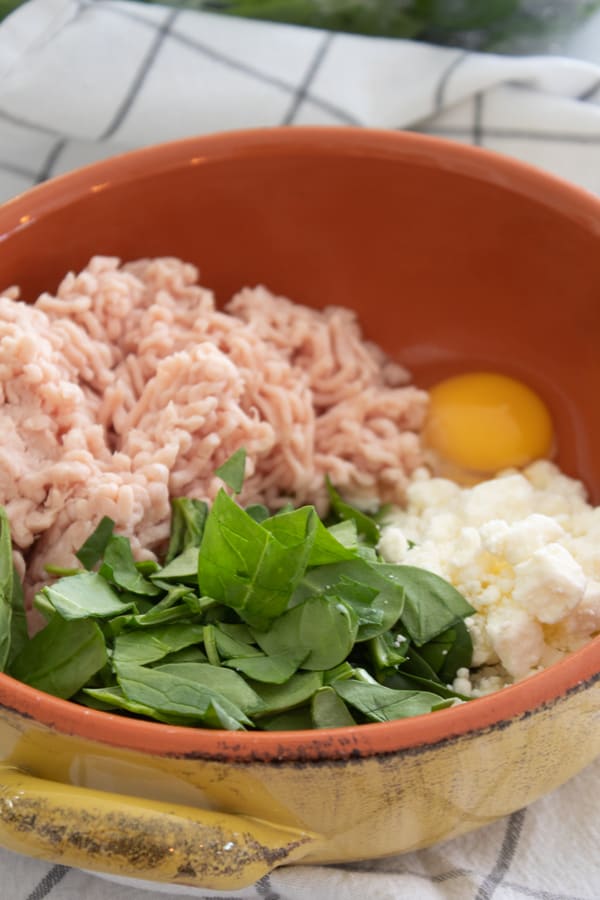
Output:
[{"xmin": 332, "ymin": 679, "xmax": 450, "ymax": 722}]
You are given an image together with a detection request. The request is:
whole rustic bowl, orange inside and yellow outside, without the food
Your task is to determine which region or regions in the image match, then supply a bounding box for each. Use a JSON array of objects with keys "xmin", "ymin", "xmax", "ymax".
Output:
[{"xmin": 0, "ymin": 128, "xmax": 600, "ymax": 890}]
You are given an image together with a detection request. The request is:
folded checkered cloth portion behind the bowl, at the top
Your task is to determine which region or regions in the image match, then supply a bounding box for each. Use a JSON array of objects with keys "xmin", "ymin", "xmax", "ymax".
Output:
[{"xmin": 0, "ymin": 0, "xmax": 600, "ymax": 200}]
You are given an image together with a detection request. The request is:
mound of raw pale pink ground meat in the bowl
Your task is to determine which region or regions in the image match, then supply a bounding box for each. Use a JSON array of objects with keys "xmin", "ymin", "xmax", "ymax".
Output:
[{"xmin": 0, "ymin": 257, "xmax": 427, "ymax": 612}]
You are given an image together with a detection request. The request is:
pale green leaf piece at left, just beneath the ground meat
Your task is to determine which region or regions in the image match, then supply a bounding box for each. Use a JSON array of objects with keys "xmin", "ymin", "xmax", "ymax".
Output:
[{"xmin": 41, "ymin": 572, "xmax": 133, "ymax": 619}]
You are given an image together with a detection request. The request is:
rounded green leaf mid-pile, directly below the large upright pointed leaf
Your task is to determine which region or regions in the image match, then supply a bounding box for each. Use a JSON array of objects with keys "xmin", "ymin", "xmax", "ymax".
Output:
[{"xmin": 253, "ymin": 596, "xmax": 358, "ymax": 670}]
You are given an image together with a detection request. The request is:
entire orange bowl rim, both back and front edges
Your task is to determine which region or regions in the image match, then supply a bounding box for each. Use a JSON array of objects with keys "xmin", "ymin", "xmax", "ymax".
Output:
[{"xmin": 0, "ymin": 126, "xmax": 600, "ymax": 762}]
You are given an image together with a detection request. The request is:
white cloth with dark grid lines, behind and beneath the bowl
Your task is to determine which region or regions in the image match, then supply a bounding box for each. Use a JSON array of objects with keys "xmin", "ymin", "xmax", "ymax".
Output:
[{"xmin": 0, "ymin": 0, "xmax": 600, "ymax": 900}]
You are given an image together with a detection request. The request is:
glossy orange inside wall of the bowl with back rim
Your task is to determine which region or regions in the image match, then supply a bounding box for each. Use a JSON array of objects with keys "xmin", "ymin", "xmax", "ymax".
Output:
[{"xmin": 0, "ymin": 128, "xmax": 600, "ymax": 760}]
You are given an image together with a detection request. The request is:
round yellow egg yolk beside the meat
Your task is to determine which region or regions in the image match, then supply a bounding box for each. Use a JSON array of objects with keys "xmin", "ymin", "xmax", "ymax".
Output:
[{"xmin": 424, "ymin": 372, "xmax": 553, "ymax": 476}]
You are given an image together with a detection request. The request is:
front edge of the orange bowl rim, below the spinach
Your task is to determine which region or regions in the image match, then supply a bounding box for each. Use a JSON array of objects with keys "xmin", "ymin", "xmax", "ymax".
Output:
[{"xmin": 0, "ymin": 636, "xmax": 600, "ymax": 762}]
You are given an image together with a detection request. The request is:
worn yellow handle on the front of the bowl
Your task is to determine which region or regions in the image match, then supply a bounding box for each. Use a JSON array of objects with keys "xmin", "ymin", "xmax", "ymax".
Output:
[{"xmin": 0, "ymin": 766, "xmax": 318, "ymax": 890}]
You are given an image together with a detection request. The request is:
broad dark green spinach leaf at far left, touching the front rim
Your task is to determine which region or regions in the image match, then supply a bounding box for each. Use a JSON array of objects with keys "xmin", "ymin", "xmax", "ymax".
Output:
[{"xmin": 10, "ymin": 615, "xmax": 107, "ymax": 699}]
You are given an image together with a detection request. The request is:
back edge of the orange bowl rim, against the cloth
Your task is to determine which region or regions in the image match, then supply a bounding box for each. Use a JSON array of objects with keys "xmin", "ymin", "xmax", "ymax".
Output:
[{"xmin": 0, "ymin": 125, "xmax": 600, "ymax": 237}]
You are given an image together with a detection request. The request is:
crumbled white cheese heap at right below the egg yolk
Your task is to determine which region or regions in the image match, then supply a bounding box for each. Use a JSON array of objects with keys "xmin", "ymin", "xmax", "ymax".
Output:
[{"xmin": 378, "ymin": 460, "xmax": 600, "ymax": 696}]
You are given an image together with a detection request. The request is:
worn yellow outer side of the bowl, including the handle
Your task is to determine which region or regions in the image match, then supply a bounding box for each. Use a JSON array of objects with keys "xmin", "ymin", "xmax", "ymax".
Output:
[{"xmin": 0, "ymin": 679, "xmax": 600, "ymax": 890}]
